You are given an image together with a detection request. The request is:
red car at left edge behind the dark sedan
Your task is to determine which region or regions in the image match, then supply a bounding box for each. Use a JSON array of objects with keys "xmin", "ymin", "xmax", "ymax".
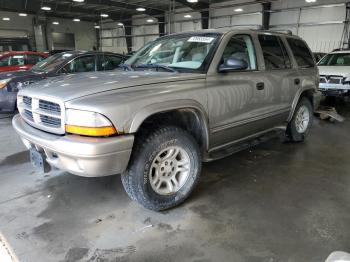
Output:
[{"xmin": 0, "ymin": 51, "xmax": 48, "ymax": 72}]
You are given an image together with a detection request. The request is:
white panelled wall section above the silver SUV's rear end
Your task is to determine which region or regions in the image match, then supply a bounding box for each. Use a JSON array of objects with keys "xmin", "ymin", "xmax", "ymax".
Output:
[{"xmin": 270, "ymin": 0, "xmax": 346, "ymax": 52}]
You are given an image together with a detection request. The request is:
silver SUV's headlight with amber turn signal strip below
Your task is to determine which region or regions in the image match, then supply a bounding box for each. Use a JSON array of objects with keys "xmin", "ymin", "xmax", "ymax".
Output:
[{"xmin": 65, "ymin": 109, "xmax": 117, "ymax": 136}]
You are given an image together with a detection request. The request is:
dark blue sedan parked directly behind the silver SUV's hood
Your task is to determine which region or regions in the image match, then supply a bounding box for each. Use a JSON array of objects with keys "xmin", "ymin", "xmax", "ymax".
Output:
[{"xmin": 0, "ymin": 51, "xmax": 126, "ymax": 112}]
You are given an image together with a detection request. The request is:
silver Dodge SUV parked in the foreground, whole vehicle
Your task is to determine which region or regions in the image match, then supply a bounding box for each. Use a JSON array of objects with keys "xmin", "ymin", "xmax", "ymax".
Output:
[{"xmin": 13, "ymin": 30, "xmax": 319, "ymax": 210}]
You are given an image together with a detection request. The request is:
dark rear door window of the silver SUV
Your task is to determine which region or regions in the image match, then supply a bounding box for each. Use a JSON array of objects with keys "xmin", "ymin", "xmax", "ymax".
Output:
[{"xmin": 259, "ymin": 35, "xmax": 291, "ymax": 70}]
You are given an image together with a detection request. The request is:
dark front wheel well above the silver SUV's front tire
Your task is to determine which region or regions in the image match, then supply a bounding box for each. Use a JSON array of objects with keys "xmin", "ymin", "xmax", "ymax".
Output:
[{"xmin": 136, "ymin": 108, "xmax": 208, "ymax": 152}]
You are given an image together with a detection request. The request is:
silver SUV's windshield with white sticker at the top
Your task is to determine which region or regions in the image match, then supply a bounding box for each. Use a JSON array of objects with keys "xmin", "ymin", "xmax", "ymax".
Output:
[{"xmin": 125, "ymin": 33, "xmax": 220, "ymax": 71}]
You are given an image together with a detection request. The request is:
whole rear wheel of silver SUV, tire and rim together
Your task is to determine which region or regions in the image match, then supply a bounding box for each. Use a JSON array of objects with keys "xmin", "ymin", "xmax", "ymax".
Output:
[{"xmin": 286, "ymin": 97, "xmax": 313, "ymax": 142}]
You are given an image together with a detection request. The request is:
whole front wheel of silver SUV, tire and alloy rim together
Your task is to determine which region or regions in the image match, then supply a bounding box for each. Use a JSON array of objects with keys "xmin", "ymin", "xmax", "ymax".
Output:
[{"xmin": 121, "ymin": 126, "xmax": 202, "ymax": 211}]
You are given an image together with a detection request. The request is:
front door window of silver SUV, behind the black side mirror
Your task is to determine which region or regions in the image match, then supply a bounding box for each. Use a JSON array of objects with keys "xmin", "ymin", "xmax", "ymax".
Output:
[{"xmin": 221, "ymin": 35, "xmax": 257, "ymax": 70}]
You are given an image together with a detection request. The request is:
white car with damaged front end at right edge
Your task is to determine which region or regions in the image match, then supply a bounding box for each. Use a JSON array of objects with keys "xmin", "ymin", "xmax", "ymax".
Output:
[{"xmin": 318, "ymin": 50, "xmax": 350, "ymax": 96}]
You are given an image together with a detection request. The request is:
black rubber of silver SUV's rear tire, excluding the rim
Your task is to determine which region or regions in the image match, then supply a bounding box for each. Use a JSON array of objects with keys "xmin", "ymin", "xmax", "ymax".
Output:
[{"xmin": 286, "ymin": 97, "xmax": 313, "ymax": 142}]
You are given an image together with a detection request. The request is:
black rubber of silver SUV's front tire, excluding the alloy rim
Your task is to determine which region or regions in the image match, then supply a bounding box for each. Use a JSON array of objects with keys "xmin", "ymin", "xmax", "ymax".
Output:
[{"xmin": 121, "ymin": 126, "xmax": 202, "ymax": 211}]
